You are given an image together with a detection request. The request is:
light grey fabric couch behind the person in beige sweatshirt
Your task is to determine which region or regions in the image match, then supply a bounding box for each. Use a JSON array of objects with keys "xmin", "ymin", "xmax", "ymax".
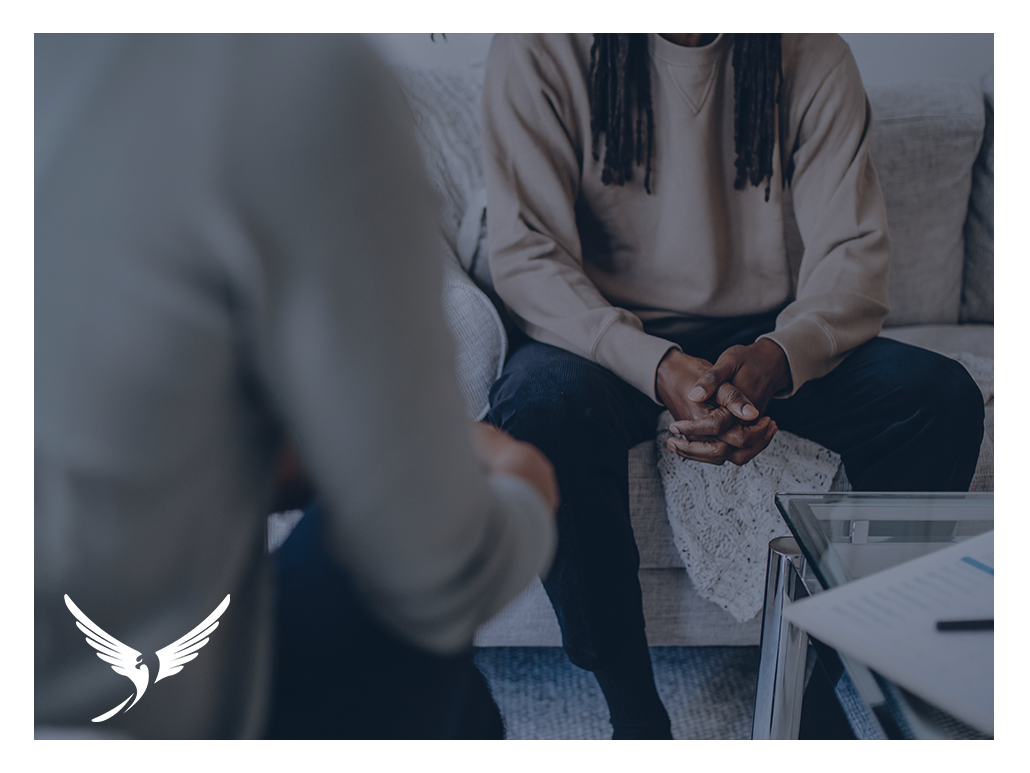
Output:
[{"xmin": 399, "ymin": 66, "xmax": 994, "ymax": 646}]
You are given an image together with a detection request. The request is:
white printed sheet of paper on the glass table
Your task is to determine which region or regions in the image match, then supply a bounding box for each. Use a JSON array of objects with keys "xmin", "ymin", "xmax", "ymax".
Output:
[{"xmin": 784, "ymin": 531, "xmax": 994, "ymax": 734}]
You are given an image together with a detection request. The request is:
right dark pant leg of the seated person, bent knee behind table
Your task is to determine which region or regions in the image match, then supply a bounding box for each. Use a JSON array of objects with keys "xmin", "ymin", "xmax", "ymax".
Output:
[{"xmin": 768, "ymin": 338, "xmax": 984, "ymax": 492}]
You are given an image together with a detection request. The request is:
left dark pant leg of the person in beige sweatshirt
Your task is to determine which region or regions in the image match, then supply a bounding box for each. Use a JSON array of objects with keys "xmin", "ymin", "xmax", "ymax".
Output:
[{"xmin": 489, "ymin": 341, "xmax": 660, "ymax": 671}]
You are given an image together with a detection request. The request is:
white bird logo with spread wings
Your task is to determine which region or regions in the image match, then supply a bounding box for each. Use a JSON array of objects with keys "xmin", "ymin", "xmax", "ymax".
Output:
[{"xmin": 65, "ymin": 594, "xmax": 229, "ymax": 722}]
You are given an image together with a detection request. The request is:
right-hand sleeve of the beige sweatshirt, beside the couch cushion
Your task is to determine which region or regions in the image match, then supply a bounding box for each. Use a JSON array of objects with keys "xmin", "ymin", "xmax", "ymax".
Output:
[{"xmin": 762, "ymin": 47, "xmax": 890, "ymax": 397}]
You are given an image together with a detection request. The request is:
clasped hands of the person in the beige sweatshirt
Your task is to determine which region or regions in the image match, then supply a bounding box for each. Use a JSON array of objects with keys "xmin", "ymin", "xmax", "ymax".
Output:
[{"xmin": 655, "ymin": 338, "xmax": 791, "ymax": 465}]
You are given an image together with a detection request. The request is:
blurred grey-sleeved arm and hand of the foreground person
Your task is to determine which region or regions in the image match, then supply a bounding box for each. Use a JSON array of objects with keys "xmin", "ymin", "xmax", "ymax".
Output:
[{"xmin": 231, "ymin": 34, "xmax": 555, "ymax": 652}]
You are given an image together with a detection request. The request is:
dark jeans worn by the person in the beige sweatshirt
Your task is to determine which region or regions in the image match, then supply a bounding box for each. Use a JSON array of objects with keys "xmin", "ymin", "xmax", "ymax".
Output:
[{"xmin": 489, "ymin": 315, "xmax": 984, "ymax": 671}]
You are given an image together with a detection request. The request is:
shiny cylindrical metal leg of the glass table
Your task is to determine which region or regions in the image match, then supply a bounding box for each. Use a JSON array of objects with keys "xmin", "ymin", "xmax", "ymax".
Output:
[{"xmin": 751, "ymin": 537, "xmax": 809, "ymax": 739}]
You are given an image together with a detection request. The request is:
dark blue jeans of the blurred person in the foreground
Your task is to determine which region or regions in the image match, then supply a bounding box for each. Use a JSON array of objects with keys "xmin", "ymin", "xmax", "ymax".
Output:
[{"xmin": 266, "ymin": 503, "xmax": 504, "ymax": 739}]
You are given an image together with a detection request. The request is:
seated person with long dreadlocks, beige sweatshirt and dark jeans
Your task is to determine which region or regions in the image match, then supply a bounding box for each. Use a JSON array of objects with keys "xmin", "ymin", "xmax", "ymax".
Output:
[{"xmin": 483, "ymin": 34, "xmax": 983, "ymax": 738}]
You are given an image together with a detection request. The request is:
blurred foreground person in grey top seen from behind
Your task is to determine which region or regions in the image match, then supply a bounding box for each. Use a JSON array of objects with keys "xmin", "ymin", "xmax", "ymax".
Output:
[{"xmin": 34, "ymin": 36, "xmax": 557, "ymax": 738}]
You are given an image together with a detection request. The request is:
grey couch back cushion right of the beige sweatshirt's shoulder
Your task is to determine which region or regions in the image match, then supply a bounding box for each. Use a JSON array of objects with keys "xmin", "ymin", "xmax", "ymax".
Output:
[{"xmin": 869, "ymin": 81, "xmax": 985, "ymax": 327}]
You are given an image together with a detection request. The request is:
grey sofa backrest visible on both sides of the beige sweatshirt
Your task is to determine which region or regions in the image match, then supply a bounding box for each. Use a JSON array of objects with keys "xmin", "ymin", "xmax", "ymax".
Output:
[{"xmin": 398, "ymin": 60, "xmax": 994, "ymax": 327}]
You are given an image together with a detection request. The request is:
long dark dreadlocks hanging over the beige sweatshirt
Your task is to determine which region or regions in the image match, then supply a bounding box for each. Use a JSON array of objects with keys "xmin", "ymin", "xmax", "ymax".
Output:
[{"xmin": 590, "ymin": 34, "xmax": 783, "ymax": 201}]
